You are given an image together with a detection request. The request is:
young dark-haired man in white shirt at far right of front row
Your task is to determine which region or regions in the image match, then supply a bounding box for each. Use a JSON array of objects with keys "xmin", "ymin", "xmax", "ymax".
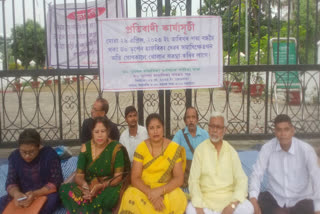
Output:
[{"xmin": 249, "ymin": 114, "xmax": 320, "ymax": 214}]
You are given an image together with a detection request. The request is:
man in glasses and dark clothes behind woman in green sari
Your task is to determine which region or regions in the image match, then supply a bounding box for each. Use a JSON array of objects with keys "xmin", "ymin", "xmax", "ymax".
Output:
[{"xmin": 80, "ymin": 97, "xmax": 120, "ymax": 143}]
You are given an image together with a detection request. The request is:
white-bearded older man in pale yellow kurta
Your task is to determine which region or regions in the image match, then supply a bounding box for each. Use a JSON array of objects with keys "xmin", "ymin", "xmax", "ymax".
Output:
[{"xmin": 187, "ymin": 112, "xmax": 254, "ymax": 214}]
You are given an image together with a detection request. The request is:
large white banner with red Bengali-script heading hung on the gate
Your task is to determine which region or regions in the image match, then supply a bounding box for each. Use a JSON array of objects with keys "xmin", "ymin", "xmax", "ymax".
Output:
[{"xmin": 99, "ymin": 16, "xmax": 223, "ymax": 91}]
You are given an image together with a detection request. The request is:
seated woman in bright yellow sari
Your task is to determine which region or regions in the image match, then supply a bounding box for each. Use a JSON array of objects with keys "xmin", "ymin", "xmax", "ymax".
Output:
[{"xmin": 119, "ymin": 113, "xmax": 187, "ymax": 214}]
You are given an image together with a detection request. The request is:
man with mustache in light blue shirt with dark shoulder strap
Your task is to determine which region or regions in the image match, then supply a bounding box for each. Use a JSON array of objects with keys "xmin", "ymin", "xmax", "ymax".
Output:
[{"xmin": 172, "ymin": 107, "xmax": 209, "ymax": 187}]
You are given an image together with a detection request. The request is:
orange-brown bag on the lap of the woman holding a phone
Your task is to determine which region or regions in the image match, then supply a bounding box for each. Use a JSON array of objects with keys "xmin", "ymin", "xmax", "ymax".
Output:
[{"xmin": 3, "ymin": 196, "xmax": 47, "ymax": 214}]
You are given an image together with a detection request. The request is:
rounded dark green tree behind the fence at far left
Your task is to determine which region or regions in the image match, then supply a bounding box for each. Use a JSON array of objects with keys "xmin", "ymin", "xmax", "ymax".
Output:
[{"xmin": 11, "ymin": 20, "xmax": 46, "ymax": 68}]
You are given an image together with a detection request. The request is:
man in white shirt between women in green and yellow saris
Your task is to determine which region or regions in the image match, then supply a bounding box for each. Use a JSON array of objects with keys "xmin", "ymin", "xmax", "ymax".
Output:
[{"xmin": 119, "ymin": 106, "xmax": 149, "ymax": 162}]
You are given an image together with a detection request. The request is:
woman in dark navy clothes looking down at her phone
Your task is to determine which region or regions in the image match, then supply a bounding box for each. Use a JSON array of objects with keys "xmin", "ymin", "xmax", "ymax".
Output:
[{"xmin": 0, "ymin": 129, "xmax": 63, "ymax": 214}]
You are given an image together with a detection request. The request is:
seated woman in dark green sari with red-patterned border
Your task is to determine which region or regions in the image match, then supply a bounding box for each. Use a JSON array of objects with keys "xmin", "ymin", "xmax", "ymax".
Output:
[{"xmin": 59, "ymin": 117, "xmax": 130, "ymax": 214}]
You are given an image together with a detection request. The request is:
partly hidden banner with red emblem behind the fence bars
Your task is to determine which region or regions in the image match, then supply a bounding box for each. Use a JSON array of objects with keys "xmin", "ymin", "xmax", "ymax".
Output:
[{"xmin": 47, "ymin": 0, "xmax": 125, "ymax": 68}]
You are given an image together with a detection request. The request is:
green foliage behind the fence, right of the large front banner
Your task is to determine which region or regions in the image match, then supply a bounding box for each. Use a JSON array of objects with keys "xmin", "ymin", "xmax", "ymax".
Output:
[{"xmin": 198, "ymin": 0, "xmax": 320, "ymax": 65}]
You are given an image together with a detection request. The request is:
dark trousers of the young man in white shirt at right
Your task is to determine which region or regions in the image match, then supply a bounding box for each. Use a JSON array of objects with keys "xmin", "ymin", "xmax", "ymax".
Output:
[{"xmin": 258, "ymin": 192, "xmax": 314, "ymax": 214}]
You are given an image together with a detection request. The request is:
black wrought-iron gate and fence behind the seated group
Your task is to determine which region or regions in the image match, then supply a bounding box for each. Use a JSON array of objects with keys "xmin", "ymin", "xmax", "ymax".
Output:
[{"xmin": 0, "ymin": 0, "xmax": 320, "ymax": 146}]
